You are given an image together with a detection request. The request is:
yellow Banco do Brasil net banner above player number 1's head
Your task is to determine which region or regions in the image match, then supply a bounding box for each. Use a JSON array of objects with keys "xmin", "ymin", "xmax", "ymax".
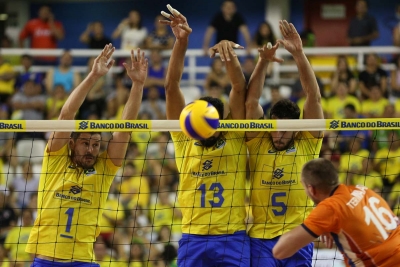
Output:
[{"xmin": 75, "ymin": 120, "xmax": 151, "ymax": 132}]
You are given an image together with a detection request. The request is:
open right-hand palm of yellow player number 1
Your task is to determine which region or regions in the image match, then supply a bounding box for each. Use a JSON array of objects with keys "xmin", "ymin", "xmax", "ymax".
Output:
[{"xmin": 123, "ymin": 48, "xmax": 149, "ymax": 84}]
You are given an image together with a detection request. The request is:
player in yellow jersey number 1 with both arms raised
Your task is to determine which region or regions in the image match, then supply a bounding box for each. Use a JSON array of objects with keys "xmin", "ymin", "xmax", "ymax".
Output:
[{"xmin": 26, "ymin": 44, "xmax": 148, "ymax": 267}]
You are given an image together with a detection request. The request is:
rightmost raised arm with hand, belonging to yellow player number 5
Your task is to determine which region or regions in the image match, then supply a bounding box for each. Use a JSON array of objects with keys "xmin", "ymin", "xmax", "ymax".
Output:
[{"xmin": 277, "ymin": 20, "xmax": 324, "ymax": 137}]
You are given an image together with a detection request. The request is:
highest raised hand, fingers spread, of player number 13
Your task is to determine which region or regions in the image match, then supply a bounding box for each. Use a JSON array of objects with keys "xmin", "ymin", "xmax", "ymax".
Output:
[{"xmin": 160, "ymin": 5, "xmax": 192, "ymax": 39}]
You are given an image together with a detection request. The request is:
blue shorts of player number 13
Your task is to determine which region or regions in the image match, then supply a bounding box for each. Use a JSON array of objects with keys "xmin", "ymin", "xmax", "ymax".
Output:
[{"xmin": 178, "ymin": 231, "xmax": 250, "ymax": 267}]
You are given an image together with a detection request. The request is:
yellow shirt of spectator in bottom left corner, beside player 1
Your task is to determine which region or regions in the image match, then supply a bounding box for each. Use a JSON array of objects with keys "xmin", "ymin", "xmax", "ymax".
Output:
[{"xmin": 4, "ymin": 226, "xmax": 32, "ymax": 262}]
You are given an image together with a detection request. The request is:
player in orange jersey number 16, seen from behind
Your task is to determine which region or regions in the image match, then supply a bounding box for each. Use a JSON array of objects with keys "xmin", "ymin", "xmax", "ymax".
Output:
[{"xmin": 273, "ymin": 158, "xmax": 400, "ymax": 267}]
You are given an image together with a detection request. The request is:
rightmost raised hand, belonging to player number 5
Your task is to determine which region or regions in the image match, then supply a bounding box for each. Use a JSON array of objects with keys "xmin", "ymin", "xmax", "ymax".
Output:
[{"xmin": 277, "ymin": 20, "xmax": 303, "ymax": 55}]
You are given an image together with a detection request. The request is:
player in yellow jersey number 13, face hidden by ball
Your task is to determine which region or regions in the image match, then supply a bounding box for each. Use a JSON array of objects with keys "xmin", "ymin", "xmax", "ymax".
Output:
[{"xmin": 162, "ymin": 6, "xmax": 250, "ymax": 267}]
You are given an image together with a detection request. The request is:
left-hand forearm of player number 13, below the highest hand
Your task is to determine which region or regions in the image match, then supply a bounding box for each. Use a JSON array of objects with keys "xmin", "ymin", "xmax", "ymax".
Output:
[{"xmin": 165, "ymin": 39, "xmax": 189, "ymax": 92}]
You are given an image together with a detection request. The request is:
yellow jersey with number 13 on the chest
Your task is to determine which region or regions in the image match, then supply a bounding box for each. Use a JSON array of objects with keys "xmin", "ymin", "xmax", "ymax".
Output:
[{"xmin": 171, "ymin": 132, "xmax": 247, "ymax": 235}]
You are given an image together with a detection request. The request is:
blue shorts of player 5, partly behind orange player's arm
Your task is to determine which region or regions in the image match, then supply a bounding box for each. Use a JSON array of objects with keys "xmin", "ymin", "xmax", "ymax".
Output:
[{"xmin": 250, "ymin": 236, "xmax": 314, "ymax": 267}]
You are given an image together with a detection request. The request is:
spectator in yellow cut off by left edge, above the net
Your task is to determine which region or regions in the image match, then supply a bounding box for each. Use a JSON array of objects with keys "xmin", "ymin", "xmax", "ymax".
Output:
[{"xmin": 0, "ymin": 53, "xmax": 16, "ymax": 104}]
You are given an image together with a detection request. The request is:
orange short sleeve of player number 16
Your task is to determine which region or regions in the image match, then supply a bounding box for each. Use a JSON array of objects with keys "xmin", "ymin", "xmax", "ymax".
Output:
[{"xmin": 303, "ymin": 202, "xmax": 340, "ymax": 236}]
